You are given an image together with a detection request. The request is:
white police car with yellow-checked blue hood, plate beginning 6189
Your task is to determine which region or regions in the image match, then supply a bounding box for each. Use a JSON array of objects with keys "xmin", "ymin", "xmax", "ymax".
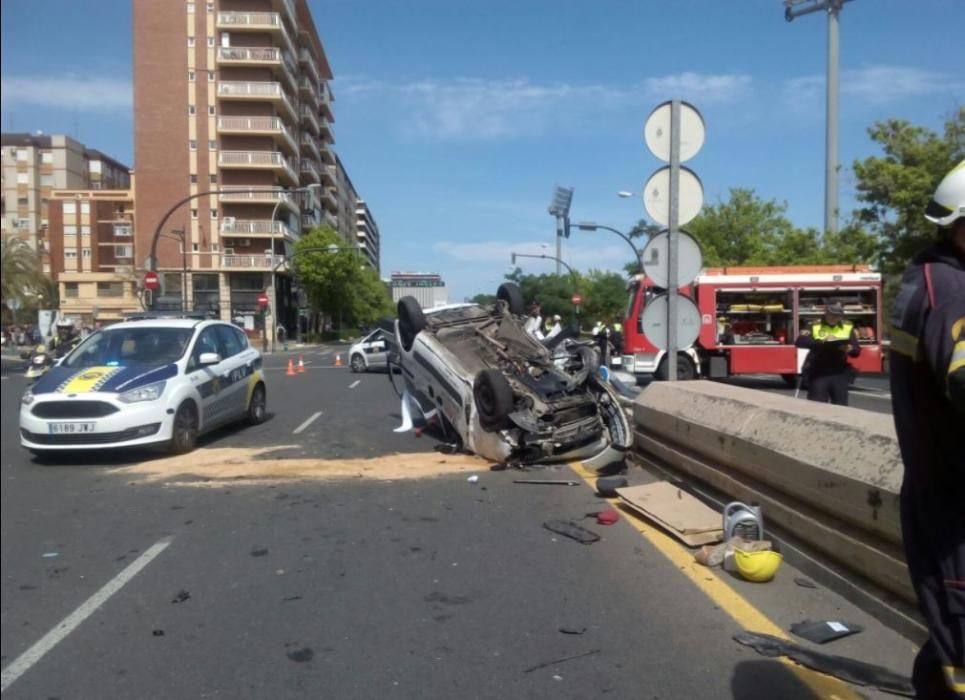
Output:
[{"xmin": 20, "ymin": 318, "xmax": 267, "ymax": 454}]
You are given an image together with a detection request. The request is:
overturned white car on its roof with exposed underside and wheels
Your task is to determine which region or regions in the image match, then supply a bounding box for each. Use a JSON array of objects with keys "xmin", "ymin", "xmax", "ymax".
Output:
[{"xmin": 390, "ymin": 283, "xmax": 632, "ymax": 473}]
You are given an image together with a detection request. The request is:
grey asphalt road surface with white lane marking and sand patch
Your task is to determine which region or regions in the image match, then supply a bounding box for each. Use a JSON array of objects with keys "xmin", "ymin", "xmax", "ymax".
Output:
[{"xmin": 0, "ymin": 348, "xmax": 913, "ymax": 699}]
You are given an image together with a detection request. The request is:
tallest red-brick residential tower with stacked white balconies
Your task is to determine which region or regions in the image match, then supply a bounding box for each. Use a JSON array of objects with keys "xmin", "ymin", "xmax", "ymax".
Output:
[{"xmin": 133, "ymin": 0, "xmax": 337, "ymax": 334}]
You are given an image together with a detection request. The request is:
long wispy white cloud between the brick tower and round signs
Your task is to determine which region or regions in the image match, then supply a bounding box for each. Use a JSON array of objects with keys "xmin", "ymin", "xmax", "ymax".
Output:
[{"xmin": 338, "ymin": 73, "xmax": 751, "ymax": 141}]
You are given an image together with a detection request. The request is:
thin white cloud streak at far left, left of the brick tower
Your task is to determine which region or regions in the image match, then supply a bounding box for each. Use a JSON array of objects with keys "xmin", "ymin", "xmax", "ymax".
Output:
[{"xmin": 0, "ymin": 74, "xmax": 133, "ymax": 112}]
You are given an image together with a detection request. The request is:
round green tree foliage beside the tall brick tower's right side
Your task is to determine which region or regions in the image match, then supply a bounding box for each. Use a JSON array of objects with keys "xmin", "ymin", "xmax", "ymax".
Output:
[{"xmin": 294, "ymin": 226, "xmax": 392, "ymax": 326}]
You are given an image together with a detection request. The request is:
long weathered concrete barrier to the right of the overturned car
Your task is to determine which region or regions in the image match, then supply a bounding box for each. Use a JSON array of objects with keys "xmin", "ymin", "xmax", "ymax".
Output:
[{"xmin": 633, "ymin": 381, "xmax": 915, "ymax": 603}]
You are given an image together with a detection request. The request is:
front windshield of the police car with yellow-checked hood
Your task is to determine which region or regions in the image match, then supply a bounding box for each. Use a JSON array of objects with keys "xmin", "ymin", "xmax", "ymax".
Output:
[{"xmin": 62, "ymin": 327, "xmax": 194, "ymax": 368}]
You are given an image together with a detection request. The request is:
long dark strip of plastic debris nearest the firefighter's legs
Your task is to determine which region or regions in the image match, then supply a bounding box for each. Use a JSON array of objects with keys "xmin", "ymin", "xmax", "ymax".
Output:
[{"xmin": 734, "ymin": 632, "xmax": 915, "ymax": 698}]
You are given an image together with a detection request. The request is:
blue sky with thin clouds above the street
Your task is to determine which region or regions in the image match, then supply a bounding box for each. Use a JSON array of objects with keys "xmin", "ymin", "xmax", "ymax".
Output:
[{"xmin": 0, "ymin": 0, "xmax": 965, "ymax": 299}]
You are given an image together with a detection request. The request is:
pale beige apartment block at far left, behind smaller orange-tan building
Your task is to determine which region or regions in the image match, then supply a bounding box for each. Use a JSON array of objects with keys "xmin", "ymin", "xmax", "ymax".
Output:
[{"xmin": 0, "ymin": 133, "xmax": 131, "ymax": 272}]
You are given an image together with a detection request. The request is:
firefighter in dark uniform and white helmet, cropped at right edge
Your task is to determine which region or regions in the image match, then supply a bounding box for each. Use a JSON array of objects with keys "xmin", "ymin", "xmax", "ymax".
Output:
[{"xmin": 890, "ymin": 161, "xmax": 965, "ymax": 699}]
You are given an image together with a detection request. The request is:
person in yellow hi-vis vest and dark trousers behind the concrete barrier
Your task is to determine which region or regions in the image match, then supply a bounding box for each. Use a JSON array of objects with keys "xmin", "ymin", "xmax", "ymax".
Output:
[{"xmin": 794, "ymin": 302, "xmax": 861, "ymax": 406}]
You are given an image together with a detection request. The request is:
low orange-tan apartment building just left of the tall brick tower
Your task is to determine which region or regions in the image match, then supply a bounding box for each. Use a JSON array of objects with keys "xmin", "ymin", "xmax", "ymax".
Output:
[{"xmin": 47, "ymin": 182, "xmax": 142, "ymax": 325}]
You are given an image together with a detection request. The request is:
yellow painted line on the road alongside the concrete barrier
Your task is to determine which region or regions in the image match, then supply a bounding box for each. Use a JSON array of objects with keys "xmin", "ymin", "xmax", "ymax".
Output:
[{"xmin": 570, "ymin": 464, "xmax": 861, "ymax": 700}]
